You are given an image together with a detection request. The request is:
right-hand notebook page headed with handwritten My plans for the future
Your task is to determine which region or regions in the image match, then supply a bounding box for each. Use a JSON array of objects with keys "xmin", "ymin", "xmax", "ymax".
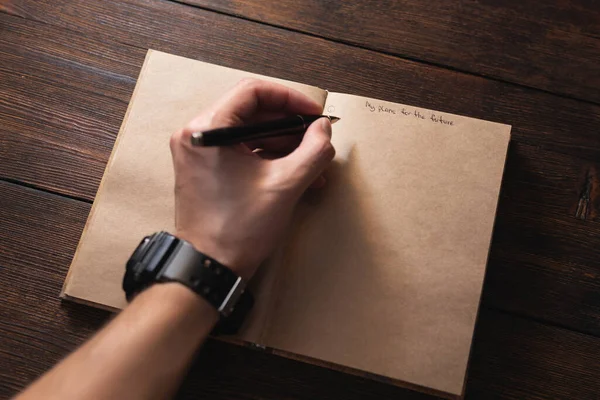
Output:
[{"xmin": 264, "ymin": 93, "xmax": 510, "ymax": 395}]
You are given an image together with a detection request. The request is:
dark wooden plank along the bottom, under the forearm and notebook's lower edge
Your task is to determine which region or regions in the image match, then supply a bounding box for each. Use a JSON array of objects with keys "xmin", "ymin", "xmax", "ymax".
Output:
[{"xmin": 0, "ymin": 182, "xmax": 600, "ymax": 399}]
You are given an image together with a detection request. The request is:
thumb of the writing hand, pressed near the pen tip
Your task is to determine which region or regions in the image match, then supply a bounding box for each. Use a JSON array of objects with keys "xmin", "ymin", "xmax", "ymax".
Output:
[{"xmin": 281, "ymin": 118, "xmax": 335, "ymax": 187}]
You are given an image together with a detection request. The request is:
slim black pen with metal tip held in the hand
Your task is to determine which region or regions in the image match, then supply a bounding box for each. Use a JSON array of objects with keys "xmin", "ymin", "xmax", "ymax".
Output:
[{"xmin": 192, "ymin": 115, "xmax": 340, "ymax": 146}]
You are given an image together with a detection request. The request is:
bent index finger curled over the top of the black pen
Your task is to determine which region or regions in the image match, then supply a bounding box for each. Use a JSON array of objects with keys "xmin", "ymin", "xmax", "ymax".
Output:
[{"xmin": 213, "ymin": 79, "xmax": 322, "ymax": 126}]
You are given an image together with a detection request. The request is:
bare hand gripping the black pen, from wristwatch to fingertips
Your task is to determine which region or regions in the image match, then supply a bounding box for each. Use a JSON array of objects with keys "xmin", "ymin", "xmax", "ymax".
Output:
[{"xmin": 171, "ymin": 79, "xmax": 335, "ymax": 279}]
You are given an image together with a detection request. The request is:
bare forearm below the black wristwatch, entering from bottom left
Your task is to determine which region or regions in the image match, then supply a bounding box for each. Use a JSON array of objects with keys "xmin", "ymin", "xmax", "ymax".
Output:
[{"xmin": 18, "ymin": 283, "xmax": 218, "ymax": 400}]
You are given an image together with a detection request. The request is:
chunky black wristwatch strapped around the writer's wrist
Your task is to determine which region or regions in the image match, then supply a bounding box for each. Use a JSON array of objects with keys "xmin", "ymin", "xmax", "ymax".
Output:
[{"xmin": 123, "ymin": 232, "xmax": 254, "ymax": 334}]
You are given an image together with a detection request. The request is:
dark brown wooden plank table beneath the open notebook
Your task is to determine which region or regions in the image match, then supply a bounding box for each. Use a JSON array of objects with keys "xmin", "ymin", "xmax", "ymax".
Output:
[{"xmin": 0, "ymin": 0, "xmax": 600, "ymax": 399}]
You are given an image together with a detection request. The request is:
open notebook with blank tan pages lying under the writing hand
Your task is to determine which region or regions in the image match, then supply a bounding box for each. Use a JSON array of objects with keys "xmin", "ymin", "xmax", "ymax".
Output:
[{"xmin": 63, "ymin": 50, "xmax": 510, "ymax": 398}]
